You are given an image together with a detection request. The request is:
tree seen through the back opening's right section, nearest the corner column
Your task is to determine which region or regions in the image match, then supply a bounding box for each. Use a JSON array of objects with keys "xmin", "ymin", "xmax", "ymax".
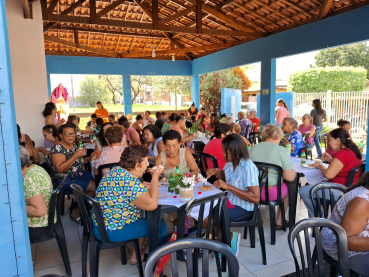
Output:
[{"xmin": 152, "ymin": 76, "xmax": 191, "ymax": 110}]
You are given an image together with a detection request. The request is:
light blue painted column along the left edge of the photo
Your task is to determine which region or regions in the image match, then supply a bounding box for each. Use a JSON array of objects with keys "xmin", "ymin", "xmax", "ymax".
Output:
[{"xmin": 0, "ymin": 0, "xmax": 33, "ymax": 276}]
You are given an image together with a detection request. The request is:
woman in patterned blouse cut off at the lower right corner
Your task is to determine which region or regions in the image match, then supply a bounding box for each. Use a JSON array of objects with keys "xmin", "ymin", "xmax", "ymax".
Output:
[{"xmin": 321, "ymin": 172, "xmax": 369, "ymax": 276}]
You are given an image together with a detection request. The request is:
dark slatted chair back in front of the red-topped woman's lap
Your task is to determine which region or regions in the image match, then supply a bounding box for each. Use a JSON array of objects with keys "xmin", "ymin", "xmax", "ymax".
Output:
[{"xmin": 309, "ymin": 183, "xmax": 346, "ymax": 218}]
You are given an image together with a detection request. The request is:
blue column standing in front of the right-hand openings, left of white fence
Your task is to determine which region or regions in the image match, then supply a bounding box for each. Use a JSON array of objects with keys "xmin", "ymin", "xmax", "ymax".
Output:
[{"xmin": 258, "ymin": 59, "xmax": 276, "ymax": 125}]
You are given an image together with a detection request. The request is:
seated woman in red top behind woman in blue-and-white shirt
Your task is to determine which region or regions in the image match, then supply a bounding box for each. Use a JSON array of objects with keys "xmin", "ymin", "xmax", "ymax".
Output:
[{"xmin": 203, "ymin": 123, "xmax": 231, "ymax": 170}]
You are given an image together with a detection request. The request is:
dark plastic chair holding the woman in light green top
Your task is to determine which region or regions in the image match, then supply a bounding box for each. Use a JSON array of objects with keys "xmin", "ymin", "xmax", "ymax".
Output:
[{"xmin": 254, "ymin": 162, "xmax": 287, "ymax": 245}]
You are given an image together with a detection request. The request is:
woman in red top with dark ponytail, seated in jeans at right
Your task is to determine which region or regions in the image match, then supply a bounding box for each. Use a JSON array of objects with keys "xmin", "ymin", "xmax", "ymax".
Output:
[{"xmin": 299, "ymin": 128, "xmax": 363, "ymax": 217}]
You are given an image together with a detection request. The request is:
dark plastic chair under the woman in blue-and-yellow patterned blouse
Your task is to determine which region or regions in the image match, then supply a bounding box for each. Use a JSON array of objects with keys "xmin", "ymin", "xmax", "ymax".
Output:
[{"xmin": 71, "ymin": 184, "xmax": 143, "ymax": 277}]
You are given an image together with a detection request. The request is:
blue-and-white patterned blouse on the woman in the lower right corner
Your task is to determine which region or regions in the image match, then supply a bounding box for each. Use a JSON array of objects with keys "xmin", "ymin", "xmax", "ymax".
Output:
[{"xmin": 322, "ymin": 187, "xmax": 369, "ymax": 260}]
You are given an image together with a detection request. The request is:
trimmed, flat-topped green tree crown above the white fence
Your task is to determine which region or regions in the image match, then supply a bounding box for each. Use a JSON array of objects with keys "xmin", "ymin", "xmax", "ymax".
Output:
[{"xmin": 288, "ymin": 66, "xmax": 367, "ymax": 93}]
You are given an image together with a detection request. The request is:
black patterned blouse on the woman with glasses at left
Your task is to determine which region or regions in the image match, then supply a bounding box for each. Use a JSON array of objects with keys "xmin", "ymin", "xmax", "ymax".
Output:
[{"xmin": 47, "ymin": 143, "xmax": 85, "ymax": 176}]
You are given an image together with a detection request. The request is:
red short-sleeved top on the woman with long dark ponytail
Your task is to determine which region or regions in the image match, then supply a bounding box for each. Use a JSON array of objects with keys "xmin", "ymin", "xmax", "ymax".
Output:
[{"xmin": 329, "ymin": 148, "xmax": 363, "ymax": 186}]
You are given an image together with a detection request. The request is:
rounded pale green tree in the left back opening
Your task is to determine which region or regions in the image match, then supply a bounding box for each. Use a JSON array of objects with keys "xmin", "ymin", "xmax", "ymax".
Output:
[{"xmin": 76, "ymin": 75, "xmax": 111, "ymax": 107}]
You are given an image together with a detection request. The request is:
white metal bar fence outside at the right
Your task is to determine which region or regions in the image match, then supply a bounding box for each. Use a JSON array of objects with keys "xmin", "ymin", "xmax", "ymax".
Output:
[{"xmin": 293, "ymin": 91, "xmax": 369, "ymax": 142}]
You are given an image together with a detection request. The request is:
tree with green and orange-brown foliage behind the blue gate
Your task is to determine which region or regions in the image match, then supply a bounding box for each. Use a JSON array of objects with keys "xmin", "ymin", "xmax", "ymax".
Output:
[{"xmin": 200, "ymin": 67, "xmax": 251, "ymax": 112}]
